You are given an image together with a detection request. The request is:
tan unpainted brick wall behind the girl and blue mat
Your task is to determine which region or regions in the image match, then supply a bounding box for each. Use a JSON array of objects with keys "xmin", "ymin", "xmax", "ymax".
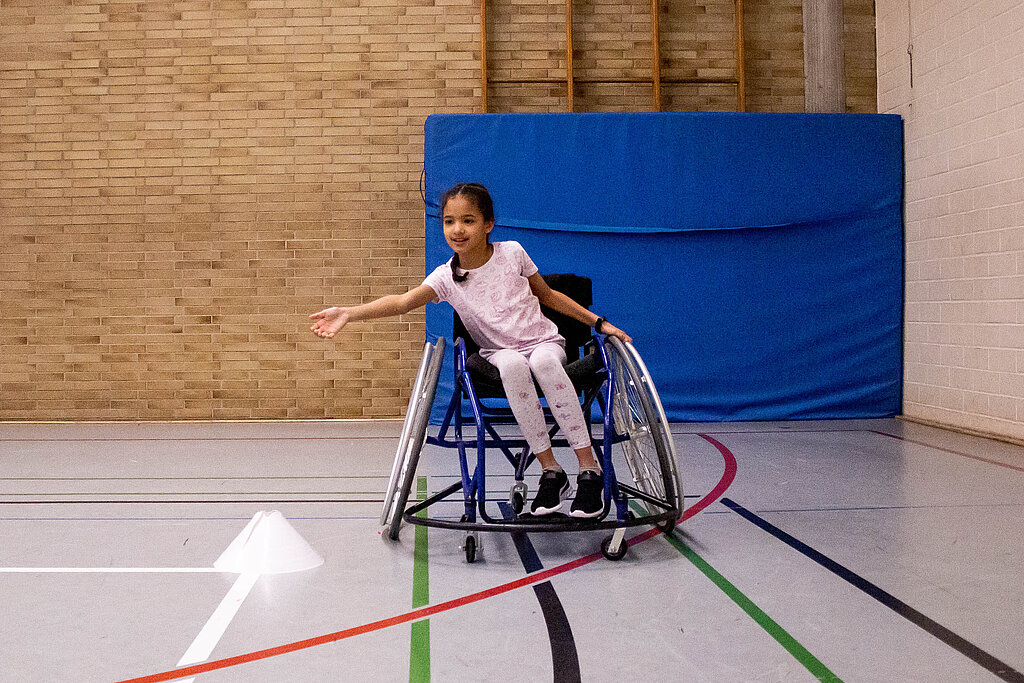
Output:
[{"xmin": 0, "ymin": 0, "xmax": 873, "ymax": 420}]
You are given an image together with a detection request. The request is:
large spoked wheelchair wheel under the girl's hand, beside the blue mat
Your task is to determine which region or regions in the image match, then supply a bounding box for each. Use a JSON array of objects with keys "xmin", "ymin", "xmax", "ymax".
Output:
[{"xmin": 605, "ymin": 337, "xmax": 683, "ymax": 531}]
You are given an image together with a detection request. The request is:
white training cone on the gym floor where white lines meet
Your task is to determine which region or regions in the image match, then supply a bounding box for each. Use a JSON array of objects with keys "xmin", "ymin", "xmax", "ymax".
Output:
[{"xmin": 213, "ymin": 510, "xmax": 324, "ymax": 573}]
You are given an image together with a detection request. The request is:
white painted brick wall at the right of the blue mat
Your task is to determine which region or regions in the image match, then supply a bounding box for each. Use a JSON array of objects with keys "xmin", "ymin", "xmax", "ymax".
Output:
[{"xmin": 876, "ymin": 0, "xmax": 1024, "ymax": 438}]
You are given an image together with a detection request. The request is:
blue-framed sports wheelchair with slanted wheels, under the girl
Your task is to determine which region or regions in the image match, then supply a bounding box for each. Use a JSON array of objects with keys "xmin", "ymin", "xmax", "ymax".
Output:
[{"xmin": 381, "ymin": 274, "xmax": 683, "ymax": 562}]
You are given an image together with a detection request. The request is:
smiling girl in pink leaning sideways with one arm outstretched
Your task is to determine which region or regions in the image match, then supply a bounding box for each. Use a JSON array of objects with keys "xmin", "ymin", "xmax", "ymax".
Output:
[{"xmin": 310, "ymin": 183, "xmax": 632, "ymax": 517}]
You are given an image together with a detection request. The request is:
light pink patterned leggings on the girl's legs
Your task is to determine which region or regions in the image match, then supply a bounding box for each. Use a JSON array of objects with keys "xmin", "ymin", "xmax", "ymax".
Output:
[{"xmin": 488, "ymin": 344, "xmax": 590, "ymax": 453}]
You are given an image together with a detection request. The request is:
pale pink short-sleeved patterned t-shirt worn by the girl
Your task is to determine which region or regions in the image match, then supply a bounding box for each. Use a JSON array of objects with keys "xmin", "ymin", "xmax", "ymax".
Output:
[{"xmin": 423, "ymin": 242, "xmax": 565, "ymax": 358}]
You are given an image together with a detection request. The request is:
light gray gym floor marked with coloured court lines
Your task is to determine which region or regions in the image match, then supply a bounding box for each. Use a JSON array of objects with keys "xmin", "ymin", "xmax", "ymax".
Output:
[{"xmin": 0, "ymin": 420, "xmax": 1024, "ymax": 683}]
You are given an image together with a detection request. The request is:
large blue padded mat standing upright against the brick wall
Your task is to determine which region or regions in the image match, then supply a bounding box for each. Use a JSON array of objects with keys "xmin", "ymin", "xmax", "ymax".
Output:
[{"xmin": 424, "ymin": 114, "xmax": 903, "ymax": 422}]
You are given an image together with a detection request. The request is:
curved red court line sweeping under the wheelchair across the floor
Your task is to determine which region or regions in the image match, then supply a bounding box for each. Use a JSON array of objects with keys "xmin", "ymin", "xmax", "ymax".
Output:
[{"xmin": 118, "ymin": 434, "xmax": 736, "ymax": 683}]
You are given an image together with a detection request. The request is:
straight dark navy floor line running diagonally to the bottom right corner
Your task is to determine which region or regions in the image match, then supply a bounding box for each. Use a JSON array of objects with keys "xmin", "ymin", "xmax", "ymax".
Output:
[{"xmin": 722, "ymin": 498, "xmax": 1024, "ymax": 683}]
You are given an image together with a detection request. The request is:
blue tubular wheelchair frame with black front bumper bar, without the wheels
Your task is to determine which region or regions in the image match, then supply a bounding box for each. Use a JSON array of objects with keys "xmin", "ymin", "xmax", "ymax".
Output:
[{"xmin": 403, "ymin": 336, "xmax": 682, "ymax": 536}]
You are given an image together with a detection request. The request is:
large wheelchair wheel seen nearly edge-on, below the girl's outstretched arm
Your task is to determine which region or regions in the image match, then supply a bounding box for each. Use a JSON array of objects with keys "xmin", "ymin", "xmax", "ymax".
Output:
[{"xmin": 381, "ymin": 337, "xmax": 444, "ymax": 541}]
